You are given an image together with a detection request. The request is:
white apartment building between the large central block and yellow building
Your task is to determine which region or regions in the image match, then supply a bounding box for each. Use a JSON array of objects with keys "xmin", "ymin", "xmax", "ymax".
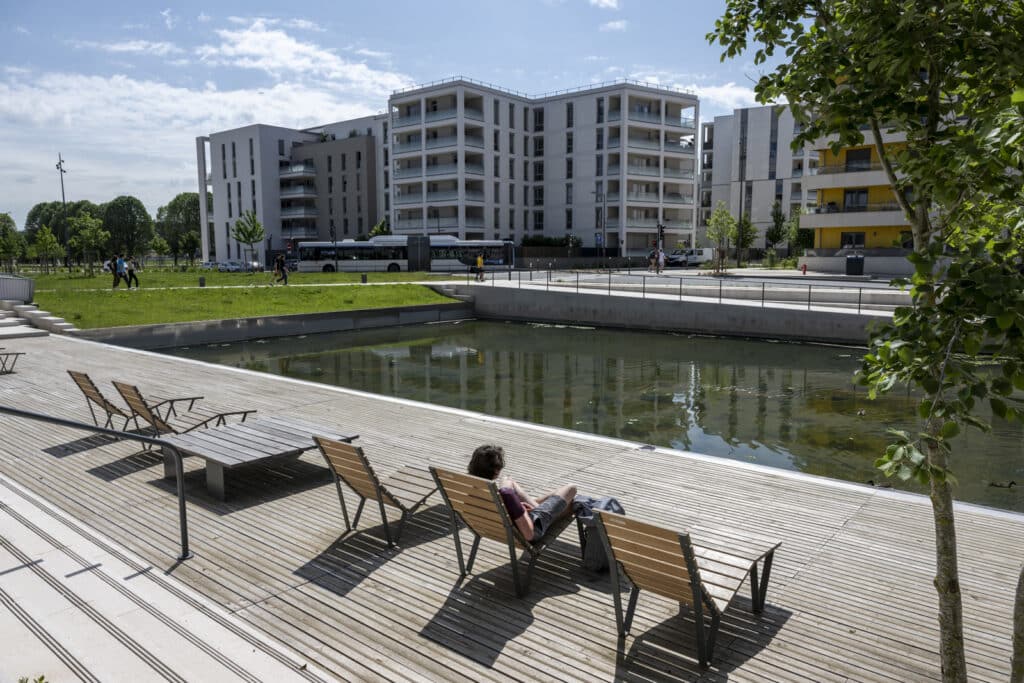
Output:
[{"xmin": 697, "ymin": 106, "xmax": 818, "ymax": 253}]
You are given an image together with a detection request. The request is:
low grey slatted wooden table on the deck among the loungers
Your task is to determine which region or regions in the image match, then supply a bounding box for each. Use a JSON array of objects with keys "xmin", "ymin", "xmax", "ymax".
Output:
[{"xmin": 161, "ymin": 416, "xmax": 358, "ymax": 500}]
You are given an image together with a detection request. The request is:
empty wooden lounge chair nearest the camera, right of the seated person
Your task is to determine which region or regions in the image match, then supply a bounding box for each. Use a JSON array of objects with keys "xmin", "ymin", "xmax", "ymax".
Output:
[{"xmin": 594, "ymin": 510, "xmax": 780, "ymax": 667}]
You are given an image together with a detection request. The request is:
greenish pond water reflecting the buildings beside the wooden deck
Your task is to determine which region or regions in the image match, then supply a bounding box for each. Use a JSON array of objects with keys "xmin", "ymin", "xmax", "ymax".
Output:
[{"xmin": 163, "ymin": 322, "xmax": 1024, "ymax": 511}]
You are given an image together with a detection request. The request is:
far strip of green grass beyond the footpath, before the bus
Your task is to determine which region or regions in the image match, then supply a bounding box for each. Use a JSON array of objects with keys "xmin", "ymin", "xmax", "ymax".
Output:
[{"xmin": 29, "ymin": 268, "xmax": 452, "ymax": 294}]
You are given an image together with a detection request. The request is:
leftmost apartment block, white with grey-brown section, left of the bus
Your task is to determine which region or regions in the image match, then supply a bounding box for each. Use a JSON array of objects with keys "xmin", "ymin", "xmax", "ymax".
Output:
[{"xmin": 196, "ymin": 115, "xmax": 388, "ymax": 260}]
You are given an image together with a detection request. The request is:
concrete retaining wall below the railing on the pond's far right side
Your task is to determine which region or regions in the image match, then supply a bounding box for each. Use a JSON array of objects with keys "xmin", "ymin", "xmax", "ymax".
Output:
[{"xmin": 459, "ymin": 287, "xmax": 878, "ymax": 346}]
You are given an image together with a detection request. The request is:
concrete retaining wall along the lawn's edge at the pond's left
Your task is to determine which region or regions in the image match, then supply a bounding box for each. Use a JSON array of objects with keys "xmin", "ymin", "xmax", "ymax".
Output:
[{"xmin": 73, "ymin": 303, "xmax": 473, "ymax": 349}]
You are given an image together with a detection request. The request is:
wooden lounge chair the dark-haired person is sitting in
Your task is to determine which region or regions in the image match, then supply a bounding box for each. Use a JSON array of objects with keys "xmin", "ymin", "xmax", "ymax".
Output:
[{"xmin": 430, "ymin": 467, "xmax": 572, "ymax": 597}]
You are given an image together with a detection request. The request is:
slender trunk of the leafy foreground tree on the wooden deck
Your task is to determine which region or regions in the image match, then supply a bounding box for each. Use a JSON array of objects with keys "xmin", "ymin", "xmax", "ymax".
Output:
[{"xmin": 927, "ymin": 436, "xmax": 967, "ymax": 683}]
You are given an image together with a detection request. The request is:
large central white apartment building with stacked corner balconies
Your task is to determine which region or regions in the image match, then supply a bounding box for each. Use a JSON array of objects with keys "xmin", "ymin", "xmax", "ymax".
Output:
[{"xmin": 388, "ymin": 78, "xmax": 698, "ymax": 254}]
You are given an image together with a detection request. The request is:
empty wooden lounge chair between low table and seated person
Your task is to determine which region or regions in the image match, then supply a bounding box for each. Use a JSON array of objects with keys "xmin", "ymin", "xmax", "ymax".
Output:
[{"xmin": 313, "ymin": 436, "xmax": 437, "ymax": 547}]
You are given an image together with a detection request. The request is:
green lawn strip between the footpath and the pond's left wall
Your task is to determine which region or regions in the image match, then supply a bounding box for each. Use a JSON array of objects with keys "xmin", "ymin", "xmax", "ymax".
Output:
[{"xmin": 36, "ymin": 284, "xmax": 452, "ymax": 330}]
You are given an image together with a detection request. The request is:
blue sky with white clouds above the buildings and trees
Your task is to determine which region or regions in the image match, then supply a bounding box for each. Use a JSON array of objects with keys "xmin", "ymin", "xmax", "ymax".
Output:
[{"xmin": 0, "ymin": 0, "xmax": 759, "ymax": 228}]
